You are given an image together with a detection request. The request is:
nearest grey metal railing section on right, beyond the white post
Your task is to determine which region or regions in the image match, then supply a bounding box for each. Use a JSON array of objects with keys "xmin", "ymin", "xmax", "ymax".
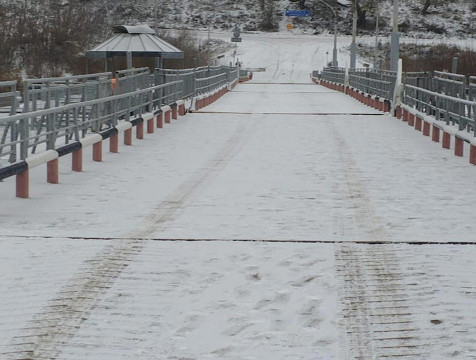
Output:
[{"xmin": 403, "ymin": 85, "xmax": 476, "ymax": 136}]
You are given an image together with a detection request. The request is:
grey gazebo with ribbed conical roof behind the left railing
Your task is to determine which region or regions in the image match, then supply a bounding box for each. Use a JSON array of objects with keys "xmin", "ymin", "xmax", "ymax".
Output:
[{"xmin": 86, "ymin": 25, "xmax": 184, "ymax": 69}]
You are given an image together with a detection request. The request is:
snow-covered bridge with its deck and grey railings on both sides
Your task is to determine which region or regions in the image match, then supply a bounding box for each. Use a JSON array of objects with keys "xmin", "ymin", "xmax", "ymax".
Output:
[{"xmin": 0, "ymin": 32, "xmax": 476, "ymax": 359}]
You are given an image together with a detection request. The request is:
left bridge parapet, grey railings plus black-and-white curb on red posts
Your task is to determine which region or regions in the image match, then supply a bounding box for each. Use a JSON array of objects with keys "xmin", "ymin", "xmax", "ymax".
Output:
[{"xmin": 0, "ymin": 66, "xmax": 239, "ymax": 197}]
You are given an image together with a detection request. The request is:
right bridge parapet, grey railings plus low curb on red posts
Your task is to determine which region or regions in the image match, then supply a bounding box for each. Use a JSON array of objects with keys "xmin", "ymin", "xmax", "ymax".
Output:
[{"xmin": 312, "ymin": 65, "xmax": 476, "ymax": 165}]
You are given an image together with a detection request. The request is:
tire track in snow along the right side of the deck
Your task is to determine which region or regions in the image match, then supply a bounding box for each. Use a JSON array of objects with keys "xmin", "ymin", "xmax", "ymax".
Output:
[{"xmin": 326, "ymin": 121, "xmax": 422, "ymax": 359}]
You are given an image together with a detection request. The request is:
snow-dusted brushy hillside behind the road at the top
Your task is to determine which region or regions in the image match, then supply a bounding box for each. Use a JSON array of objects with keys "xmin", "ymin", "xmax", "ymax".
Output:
[{"xmin": 107, "ymin": 0, "xmax": 476, "ymax": 38}]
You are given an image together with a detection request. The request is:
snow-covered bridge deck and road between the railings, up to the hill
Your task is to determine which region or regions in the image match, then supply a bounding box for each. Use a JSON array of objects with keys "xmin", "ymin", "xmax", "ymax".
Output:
[{"xmin": 0, "ymin": 34, "xmax": 476, "ymax": 360}]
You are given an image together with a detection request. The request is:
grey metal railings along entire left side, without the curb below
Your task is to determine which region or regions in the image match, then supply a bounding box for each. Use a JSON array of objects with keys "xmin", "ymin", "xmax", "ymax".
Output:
[{"xmin": 0, "ymin": 66, "xmax": 238, "ymax": 167}]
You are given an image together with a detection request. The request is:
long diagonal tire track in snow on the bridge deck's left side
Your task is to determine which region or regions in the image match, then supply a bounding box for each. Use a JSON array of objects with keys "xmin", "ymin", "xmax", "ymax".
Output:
[{"xmin": 4, "ymin": 121, "xmax": 253, "ymax": 360}]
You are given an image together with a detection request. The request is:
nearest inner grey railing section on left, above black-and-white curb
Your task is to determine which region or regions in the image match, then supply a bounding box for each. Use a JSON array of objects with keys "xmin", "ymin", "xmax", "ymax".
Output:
[{"xmin": 0, "ymin": 81, "xmax": 183, "ymax": 163}]
